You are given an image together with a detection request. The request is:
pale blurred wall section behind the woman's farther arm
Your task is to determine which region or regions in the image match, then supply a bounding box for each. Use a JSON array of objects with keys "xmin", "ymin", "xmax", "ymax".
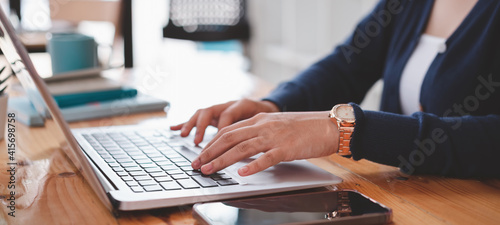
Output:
[{"xmin": 247, "ymin": 0, "xmax": 378, "ymax": 83}]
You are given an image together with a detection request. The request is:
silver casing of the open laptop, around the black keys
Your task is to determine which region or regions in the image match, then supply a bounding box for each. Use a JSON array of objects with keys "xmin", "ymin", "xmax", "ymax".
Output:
[{"xmin": 0, "ymin": 6, "xmax": 342, "ymax": 211}]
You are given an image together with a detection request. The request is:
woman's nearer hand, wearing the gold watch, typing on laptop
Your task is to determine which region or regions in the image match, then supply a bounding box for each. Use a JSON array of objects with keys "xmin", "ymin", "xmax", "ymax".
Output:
[{"xmin": 191, "ymin": 112, "xmax": 339, "ymax": 176}]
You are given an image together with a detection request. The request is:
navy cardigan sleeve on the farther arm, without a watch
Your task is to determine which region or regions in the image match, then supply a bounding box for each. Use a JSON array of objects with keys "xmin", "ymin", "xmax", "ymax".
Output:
[{"xmin": 264, "ymin": 0, "xmax": 403, "ymax": 111}]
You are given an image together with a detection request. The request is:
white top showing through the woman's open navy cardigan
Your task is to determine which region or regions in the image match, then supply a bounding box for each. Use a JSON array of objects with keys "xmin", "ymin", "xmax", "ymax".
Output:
[{"xmin": 399, "ymin": 34, "xmax": 446, "ymax": 115}]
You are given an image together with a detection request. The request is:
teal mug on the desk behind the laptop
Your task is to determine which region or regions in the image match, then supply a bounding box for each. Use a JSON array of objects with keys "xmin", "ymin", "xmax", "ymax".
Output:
[{"xmin": 47, "ymin": 33, "xmax": 98, "ymax": 75}]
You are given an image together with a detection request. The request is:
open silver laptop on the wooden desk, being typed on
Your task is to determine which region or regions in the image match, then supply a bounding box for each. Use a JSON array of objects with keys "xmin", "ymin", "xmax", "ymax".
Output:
[{"xmin": 0, "ymin": 9, "xmax": 341, "ymax": 211}]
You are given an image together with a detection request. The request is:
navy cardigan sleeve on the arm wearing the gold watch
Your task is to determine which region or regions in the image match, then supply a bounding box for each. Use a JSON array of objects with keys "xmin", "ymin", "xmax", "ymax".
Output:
[{"xmin": 351, "ymin": 103, "xmax": 500, "ymax": 178}]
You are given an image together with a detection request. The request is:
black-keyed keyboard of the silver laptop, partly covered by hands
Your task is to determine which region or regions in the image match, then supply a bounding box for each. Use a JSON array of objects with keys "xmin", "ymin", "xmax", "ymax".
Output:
[{"xmin": 83, "ymin": 130, "xmax": 238, "ymax": 193}]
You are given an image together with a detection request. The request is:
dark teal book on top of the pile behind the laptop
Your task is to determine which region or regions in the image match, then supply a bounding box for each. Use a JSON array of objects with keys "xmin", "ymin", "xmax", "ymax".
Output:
[{"xmin": 54, "ymin": 87, "xmax": 137, "ymax": 108}]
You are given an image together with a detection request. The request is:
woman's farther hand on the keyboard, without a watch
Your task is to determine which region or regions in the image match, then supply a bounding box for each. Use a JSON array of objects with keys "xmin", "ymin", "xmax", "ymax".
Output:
[{"xmin": 170, "ymin": 99, "xmax": 279, "ymax": 145}]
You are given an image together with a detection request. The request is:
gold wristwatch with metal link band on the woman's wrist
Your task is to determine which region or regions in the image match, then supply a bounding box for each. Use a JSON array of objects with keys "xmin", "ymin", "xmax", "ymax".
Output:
[{"xmin": 329, "ymin": 104, "xmax": 356, "ymax": 157}]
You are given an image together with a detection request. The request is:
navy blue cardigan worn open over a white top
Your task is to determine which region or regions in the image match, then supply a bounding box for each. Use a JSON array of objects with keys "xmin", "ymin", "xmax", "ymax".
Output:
[{"xmin": 265, "ymin": 0, "xmax": 500, "ymax": 177}]
